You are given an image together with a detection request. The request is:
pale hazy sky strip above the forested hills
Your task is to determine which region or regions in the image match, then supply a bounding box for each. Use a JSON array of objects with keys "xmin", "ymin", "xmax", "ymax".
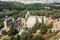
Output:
[{"xmin": 0, "ymin": 0, "xmax": 60, "ymax": 3}]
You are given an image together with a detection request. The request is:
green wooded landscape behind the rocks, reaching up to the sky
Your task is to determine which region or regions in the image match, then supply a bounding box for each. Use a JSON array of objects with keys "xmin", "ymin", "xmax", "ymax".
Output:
[{"xmin": 0, "ymin": 1, "xmax": 60, "ymax": 27}]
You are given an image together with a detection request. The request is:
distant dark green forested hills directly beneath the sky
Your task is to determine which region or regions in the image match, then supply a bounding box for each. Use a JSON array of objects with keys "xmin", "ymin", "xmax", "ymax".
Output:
[{"xmin": 0, "ymin": 2, "xmax": 60, "ymax": 10}]
